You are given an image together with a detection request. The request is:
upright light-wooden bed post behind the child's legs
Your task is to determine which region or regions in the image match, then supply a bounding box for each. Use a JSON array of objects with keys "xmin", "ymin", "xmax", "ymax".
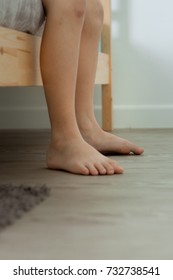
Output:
[{"xmin": 101, "ymin": 0, "xmax": 113, "ymax": 131}]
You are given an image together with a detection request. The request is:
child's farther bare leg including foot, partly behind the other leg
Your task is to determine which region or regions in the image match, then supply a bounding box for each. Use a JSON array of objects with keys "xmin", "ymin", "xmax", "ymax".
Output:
[{"xmin": 76, "ymin": 0, "xmax": 143, "ymax": 154}]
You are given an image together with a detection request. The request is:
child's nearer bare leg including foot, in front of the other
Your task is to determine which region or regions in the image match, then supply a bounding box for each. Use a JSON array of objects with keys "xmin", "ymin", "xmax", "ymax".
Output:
[{"xmin": 41, "ymin": 0, "xmax": 123, "ymax": 175}]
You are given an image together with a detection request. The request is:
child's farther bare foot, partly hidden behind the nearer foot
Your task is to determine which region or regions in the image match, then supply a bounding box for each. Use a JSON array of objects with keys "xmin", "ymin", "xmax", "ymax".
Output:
[{"xmin": 80, "ymin": 121, "xmax": 144, "ymax": 155}]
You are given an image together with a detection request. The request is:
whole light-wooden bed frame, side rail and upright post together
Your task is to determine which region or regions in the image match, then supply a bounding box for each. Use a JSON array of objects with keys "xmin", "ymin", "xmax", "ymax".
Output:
[{"xmin": 0, "ymin": 0, "xmax": 112, "ymax": 131}]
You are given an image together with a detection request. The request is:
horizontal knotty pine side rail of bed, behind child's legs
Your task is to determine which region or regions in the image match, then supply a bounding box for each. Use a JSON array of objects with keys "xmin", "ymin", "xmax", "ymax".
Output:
[{"xmin": 0, "ymin": 27, "xmax": 109, "ymax": 86}]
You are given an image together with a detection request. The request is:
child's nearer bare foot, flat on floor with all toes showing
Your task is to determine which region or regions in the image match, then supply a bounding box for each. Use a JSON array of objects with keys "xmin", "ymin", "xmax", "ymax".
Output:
[{"xmin": 47, "ymin": 137, "xmax": 123, "ymax": 175}]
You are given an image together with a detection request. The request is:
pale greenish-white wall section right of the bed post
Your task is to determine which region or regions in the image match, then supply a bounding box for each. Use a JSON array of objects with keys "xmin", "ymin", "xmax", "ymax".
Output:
[{"xmin": 112, "ymin": 0, "xmax": 173, "ymax": 128}]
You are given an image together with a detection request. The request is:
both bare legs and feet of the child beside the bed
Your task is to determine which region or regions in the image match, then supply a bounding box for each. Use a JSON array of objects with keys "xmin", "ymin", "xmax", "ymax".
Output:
[{"xmin": 41, "ymin": 0, "xmax": 142, "ymax": 175}]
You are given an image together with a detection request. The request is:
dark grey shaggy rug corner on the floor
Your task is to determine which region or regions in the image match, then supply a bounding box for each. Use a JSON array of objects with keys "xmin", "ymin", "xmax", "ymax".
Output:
[{"xmin": 0, "ymin": 185, "xmax": 50, "ymax": 231}]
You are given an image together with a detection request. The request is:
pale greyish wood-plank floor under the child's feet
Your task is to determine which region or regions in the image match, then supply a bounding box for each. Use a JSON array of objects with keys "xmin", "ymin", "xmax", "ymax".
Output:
[{"xmin": 0, "ymin": 130, "xmax": 173, "ymax": 259}]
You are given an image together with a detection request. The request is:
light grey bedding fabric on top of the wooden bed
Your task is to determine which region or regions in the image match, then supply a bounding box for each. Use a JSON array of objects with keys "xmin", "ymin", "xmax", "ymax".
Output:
[{"xmin": 0, "ymin": 0, "xmax": 45, "ymax": 34}]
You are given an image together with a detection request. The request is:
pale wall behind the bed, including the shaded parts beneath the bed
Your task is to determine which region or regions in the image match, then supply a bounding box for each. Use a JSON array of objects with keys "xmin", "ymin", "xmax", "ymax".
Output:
[{"xmin": 0, "ymin": 0, "xmax": 173, "ymax": 128}]
